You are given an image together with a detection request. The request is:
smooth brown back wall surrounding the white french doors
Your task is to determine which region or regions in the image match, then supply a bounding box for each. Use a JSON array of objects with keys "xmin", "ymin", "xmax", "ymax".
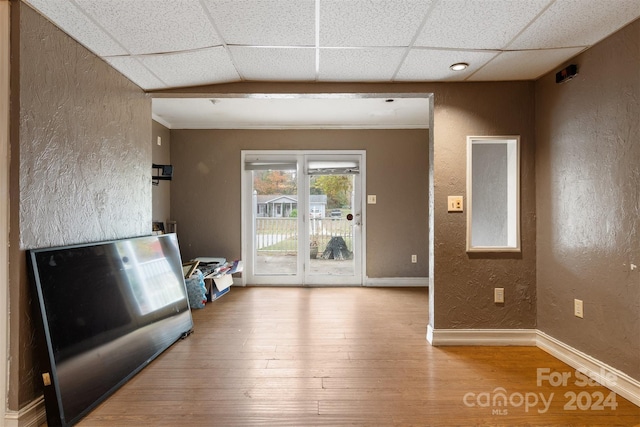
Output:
[{"xmin": 171, "ymin": 130, "xmax": 429, "ymax": 277}]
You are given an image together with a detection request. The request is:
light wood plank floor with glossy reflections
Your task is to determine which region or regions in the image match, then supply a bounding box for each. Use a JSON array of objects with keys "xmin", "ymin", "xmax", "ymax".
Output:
[{"xmin": 78, "ymin": 287, "xmax": 640, "ymax": 427}]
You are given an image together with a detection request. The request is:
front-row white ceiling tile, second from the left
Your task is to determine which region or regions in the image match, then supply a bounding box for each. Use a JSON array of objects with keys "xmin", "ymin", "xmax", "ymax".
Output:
[{"xmin": 76, "ymin": 0, "xmax": 222, "ymax": 55}]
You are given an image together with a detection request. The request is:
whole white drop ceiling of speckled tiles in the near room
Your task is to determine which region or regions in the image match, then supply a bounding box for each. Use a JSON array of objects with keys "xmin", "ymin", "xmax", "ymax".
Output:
[{"xmin": 25, "ymin": 0, "xmax": 640, "ymax": 126}]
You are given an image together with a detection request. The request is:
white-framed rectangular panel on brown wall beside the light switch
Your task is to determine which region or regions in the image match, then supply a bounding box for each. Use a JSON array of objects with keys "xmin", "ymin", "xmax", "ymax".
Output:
[{"xmin": 467, "ymin": 136, "xmax": 520, "ymax": 252}]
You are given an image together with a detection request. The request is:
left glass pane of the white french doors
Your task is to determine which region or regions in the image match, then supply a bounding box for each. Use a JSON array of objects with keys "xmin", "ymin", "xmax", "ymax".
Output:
[{"xmin": 252, "ymin": 168, "xmax": 299, "ymax": 275}]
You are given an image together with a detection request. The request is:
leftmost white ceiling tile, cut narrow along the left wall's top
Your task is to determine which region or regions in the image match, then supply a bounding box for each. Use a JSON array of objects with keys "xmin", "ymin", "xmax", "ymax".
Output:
[{"xmin": 28, "ymin": 0, "xmax": 127, "ymax": 56}]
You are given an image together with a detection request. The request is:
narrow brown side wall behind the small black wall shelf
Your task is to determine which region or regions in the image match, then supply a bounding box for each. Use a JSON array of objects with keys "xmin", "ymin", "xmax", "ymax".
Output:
[{"xmin": 149, "ymin": 121, "xmax": 171, "ymax": 227}]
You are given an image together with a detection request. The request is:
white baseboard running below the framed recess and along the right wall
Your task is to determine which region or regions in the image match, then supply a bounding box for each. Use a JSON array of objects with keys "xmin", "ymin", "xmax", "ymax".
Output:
[{"xmin": 427, "ymin": 325, "xmax": 640, "ymax": 406}]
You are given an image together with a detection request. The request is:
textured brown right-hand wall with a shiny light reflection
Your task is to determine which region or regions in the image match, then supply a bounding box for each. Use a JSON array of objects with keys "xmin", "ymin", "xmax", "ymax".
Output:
[{"xmin": 536, "ymin": 21, "xmax": 640, "ymax": 380}]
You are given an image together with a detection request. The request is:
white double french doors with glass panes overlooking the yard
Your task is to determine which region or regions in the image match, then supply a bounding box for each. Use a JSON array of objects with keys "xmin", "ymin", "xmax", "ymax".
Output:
[{"xmin": 242, "ymin": 151, "xmax": 365, "ymax": 286}]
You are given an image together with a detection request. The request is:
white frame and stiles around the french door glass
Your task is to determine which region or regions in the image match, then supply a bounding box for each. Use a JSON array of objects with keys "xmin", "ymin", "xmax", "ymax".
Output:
[{"xmin": 240, "ymin": 150, "xmax": 366, "ymax": 286}]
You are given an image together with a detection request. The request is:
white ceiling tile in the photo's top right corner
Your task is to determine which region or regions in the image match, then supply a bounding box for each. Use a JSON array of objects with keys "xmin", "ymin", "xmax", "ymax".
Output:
[{"xmin": 509, "ymin": 0, "xmax": 640, "ymax": 49}]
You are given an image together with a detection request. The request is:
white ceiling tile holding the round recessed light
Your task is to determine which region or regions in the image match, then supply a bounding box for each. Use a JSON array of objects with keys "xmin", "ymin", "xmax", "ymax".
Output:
[{"xmin": 395, "ymin": 49, "xmax": 499, "ymax": 81}]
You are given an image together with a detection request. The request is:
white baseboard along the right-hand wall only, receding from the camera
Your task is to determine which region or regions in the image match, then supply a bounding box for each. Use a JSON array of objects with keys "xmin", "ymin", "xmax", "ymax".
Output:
[{"xmin": 537, "ymin": 331, "xmax": 640, "ymax": 406}]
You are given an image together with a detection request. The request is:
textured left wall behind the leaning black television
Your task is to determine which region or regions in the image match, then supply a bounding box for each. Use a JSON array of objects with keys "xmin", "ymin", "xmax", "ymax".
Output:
[{"xmin": 9, "ymin": 2, "xmax": 151, "ymax": 410}]
